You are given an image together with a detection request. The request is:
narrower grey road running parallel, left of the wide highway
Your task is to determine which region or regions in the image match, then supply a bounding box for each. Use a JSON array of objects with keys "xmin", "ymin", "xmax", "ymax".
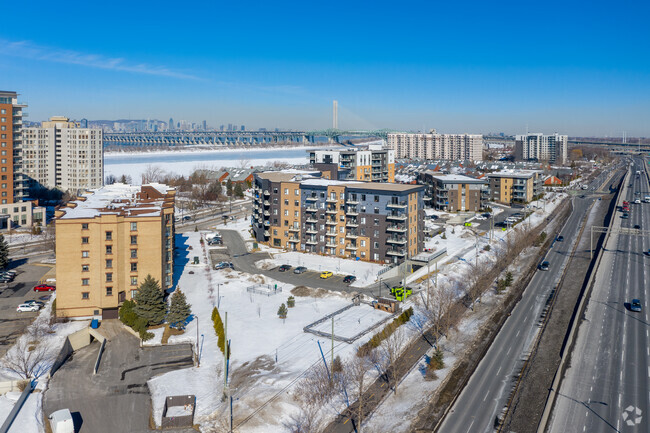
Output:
[{"xmin": 438, "ymin": 173, "xmax": 609, "ymax": 433}]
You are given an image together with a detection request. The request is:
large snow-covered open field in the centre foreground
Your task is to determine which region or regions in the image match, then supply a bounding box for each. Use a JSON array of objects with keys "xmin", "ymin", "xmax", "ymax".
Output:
[{"xmin": 149, "ymin": 233, "xmax": 386, "ymax": 432}]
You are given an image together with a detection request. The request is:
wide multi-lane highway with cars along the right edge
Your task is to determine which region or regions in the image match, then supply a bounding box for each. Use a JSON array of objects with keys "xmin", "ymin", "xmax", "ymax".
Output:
[{"xmin": 548, "ymin": 158, "xmax": 650, "ymax": 433}]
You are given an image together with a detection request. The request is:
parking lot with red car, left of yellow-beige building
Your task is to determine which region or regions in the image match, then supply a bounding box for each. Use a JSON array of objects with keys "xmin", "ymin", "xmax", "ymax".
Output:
[{"xmin": 0, "ymin": 263, "xmax": 51, "ymax": 357}]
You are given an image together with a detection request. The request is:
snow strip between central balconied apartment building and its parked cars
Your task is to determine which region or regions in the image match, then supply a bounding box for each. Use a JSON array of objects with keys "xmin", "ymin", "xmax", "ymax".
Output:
[{"xmin": 257, "ymin": 249, "xmax": 385, "ymax": 287}]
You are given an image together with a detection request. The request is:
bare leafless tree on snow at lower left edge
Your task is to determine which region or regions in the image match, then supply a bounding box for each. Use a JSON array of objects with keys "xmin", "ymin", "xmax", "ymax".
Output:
[{"xmin": 0, "ymin": 338, "xmax": 51, "ymax": 379}]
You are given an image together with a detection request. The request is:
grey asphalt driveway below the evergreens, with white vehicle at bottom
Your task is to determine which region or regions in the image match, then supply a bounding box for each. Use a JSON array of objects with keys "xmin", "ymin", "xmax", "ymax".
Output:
[{"xmin": 43, "ymin": 330, "xmax": 194, "ymax": 433}]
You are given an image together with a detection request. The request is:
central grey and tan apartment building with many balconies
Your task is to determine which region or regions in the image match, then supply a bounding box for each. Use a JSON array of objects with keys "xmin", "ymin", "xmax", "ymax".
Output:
[{"xmin": 251, "ymin": 172, "xmax": 424, "ymax": 263}]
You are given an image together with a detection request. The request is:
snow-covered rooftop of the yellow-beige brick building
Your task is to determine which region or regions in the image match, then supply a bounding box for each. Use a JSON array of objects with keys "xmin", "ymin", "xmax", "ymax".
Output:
[{"xmin": 57, "ymin": 183, "xmax": 175, "ymax": 219}]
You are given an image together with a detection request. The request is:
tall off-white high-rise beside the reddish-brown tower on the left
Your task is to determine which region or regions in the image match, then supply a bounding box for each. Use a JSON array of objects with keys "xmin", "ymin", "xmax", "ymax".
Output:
[{"xmin": 22, "ymin": 116, "xmax": 104, "ymax": 193}]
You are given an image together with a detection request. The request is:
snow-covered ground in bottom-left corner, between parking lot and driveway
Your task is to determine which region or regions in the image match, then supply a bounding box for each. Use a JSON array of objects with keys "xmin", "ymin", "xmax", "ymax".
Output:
[{"xmin": 0, "ymin": 298, "xmax": 89, "ymax": 433}]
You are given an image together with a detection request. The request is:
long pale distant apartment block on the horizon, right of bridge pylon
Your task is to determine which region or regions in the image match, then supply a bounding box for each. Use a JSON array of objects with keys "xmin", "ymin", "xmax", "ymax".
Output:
[{"xmin": 387, "ymin": 129, "xmax": 483, "ymax": 161}]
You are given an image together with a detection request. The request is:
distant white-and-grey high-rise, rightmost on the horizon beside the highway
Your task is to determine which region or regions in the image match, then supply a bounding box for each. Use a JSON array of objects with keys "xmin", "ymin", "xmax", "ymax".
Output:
[{"xmin": 515, "ymin": 133, "xmax": 569, "ymax": 164}]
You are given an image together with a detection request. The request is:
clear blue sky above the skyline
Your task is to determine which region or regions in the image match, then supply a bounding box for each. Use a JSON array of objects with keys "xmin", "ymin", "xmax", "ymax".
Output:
[{"xmin": 0, "ymin": 1, "xmax": 650, "ymax": 136}]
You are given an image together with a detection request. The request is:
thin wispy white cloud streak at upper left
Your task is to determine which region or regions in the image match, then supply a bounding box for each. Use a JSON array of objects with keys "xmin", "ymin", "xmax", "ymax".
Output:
[{"xmin": 0, "ymin": 39, "xmax": 200, "ymax": 80}]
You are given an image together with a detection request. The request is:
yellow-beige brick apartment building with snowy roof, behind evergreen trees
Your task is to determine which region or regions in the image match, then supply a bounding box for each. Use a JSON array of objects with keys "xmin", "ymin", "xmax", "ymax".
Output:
[{"xmin": 55, "ymin": 183, "xmax": 176, "ymax": 318}]
